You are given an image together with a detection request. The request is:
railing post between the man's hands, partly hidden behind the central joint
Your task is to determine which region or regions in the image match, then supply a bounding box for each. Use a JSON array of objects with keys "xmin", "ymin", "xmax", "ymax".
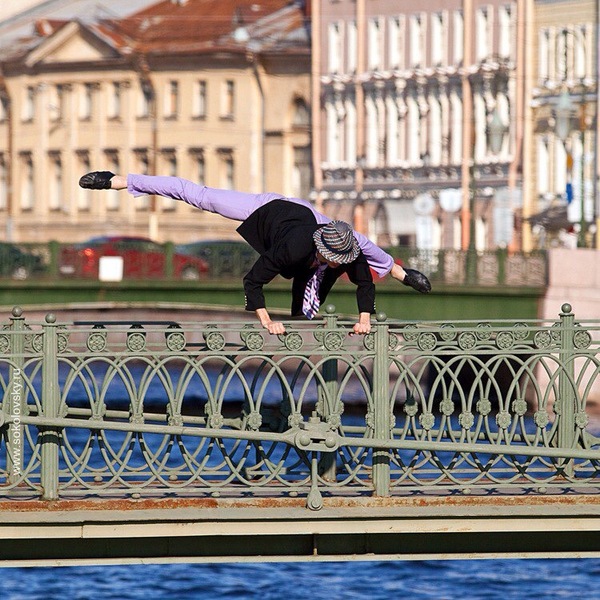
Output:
[{"xmin": 317, "ymin": 304, "xmax": 339, "ymax": 481}]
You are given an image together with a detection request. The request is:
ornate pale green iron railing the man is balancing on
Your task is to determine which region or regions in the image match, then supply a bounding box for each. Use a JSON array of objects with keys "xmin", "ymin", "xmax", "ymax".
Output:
[{"xmin": 0, "ymin": 304, "xmax": 600, "ymax": 509}]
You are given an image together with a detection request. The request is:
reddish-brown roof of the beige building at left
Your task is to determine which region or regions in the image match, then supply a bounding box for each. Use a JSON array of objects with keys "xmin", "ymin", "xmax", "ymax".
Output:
[{"xmin": 0, "ymin": 0, "xmax": 310, "ymax": 61}]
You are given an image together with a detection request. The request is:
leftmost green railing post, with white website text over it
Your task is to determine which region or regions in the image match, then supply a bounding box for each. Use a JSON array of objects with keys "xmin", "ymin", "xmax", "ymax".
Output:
[{"xmin": 4, "ymin": 306, "xmax": 25, "ymax": 483}]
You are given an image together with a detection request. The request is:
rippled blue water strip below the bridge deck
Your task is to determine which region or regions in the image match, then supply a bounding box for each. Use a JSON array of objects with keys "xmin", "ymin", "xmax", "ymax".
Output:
[{"xmin": 0, "ymin": 559, "xmax": 600, "ymax": 600}]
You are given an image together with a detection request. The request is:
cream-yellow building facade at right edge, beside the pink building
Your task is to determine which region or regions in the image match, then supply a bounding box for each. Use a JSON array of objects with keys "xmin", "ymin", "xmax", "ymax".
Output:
[{"xmin": 525, "ymin": 0, "xmax": 600, "ymax": 248}]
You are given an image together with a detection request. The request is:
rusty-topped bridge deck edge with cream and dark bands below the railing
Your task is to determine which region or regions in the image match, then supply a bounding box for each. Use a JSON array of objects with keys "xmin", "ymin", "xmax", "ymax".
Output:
[{"xmin": 0, "ymin": 495, "xmax": 600, "ymax": 566}]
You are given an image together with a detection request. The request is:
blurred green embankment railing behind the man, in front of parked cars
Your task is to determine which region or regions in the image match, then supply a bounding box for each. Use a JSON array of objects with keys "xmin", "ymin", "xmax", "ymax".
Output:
[{"xmin": 0, "ymin": 241, "xmax": 548, "ymax": 288}]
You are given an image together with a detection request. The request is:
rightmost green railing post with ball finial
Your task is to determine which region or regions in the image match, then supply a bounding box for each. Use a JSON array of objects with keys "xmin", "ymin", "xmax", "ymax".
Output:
[{"xmin": 554, "ymin": 303, "xmax": 577, "ymax": 475}]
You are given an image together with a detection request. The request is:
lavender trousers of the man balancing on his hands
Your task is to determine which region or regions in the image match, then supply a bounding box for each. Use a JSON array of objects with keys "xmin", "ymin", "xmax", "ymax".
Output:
[{"xmin": 127, "ymin": 174, "xmax": 394, "ymax": 277}]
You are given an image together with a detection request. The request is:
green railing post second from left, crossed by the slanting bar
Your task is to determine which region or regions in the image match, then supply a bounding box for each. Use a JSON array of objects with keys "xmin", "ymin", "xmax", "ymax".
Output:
[{"xmin": 40, "ymin": 314, "xmax": 60, "ymax": 500}]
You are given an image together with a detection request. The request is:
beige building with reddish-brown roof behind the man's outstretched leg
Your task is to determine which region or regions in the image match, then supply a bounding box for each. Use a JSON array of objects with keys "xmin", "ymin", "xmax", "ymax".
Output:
[{"xmin": 0, "ymin": 0, "xmax": 311, "ymax": 242}]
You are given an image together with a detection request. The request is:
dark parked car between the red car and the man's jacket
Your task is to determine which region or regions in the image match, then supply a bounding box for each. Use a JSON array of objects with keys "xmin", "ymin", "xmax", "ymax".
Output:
[{"xmin": 175, "ymin": 240, "xmax": 258, "ymax": 277}]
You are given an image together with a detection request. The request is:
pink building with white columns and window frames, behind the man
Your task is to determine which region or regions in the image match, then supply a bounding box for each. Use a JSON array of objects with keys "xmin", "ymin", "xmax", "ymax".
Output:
[{"xmin": 312, "ymin": 0, "xmax": 598, "ymax": 250}]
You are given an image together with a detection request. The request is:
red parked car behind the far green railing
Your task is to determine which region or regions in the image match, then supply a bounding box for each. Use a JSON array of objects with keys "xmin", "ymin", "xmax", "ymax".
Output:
[{"xmin": 59, "ymin": 236, "xmax": 208, "ymax": 280}]
